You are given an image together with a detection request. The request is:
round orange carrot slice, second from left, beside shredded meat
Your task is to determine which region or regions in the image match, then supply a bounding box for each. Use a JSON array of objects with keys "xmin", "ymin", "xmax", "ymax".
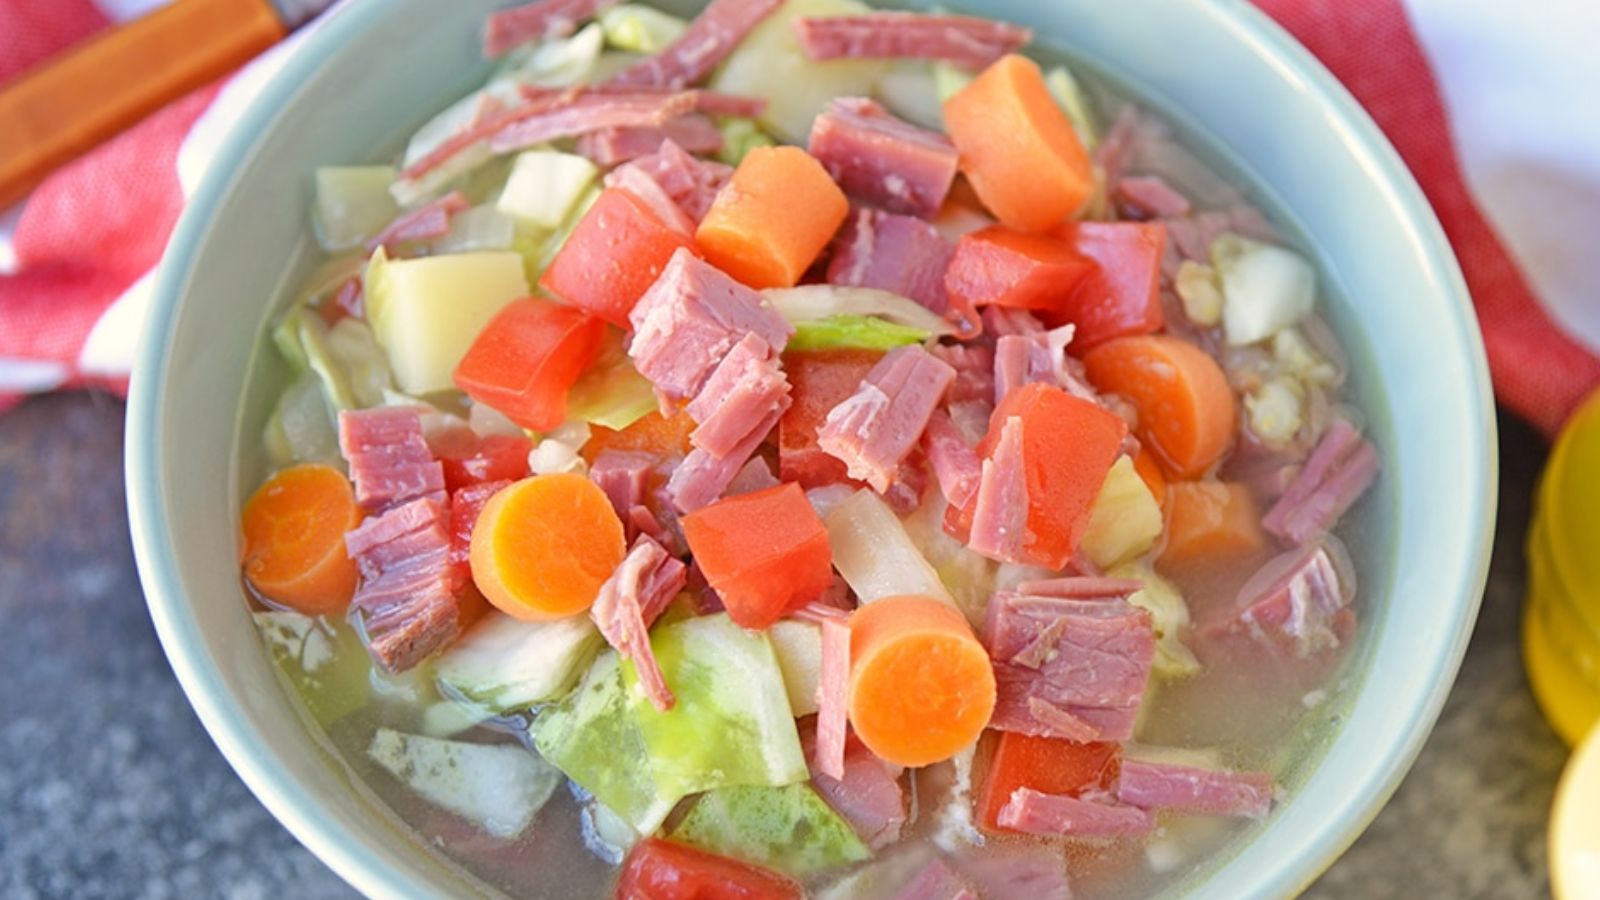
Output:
[{"xmin": 472, "ymin": 472, "xmax": 626, "ymax": 621}]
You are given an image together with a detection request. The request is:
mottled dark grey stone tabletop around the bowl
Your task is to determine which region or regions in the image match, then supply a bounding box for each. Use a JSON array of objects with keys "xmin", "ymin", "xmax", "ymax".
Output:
[{"xmin": 0, "ymin": 394, "xmax": 1565, "ymax": 900}]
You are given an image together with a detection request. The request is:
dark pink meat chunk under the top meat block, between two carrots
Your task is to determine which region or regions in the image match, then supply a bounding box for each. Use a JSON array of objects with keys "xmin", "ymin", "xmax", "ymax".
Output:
[{"xmin": 827, "ymin": 207, "xmax": 960, "ymax": 329}]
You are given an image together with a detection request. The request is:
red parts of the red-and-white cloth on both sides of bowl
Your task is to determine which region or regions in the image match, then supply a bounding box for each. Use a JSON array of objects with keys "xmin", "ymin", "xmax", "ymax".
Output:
[{"xmin": 0, "ymin": 0, "xmax": 1600, "ymax": 436}]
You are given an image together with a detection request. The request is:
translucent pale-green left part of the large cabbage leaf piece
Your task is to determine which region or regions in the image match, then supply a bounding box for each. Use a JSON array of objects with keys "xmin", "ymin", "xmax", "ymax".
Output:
[{"xmin": 531, "ymin": 650, "xmax": 681, "ymax": 834}]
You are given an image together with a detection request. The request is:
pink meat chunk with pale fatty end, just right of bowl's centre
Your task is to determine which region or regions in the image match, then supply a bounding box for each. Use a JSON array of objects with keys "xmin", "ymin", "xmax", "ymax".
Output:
[{"xmin": 816, "ymin": 346, "xmax": 955, "ymax": 493}]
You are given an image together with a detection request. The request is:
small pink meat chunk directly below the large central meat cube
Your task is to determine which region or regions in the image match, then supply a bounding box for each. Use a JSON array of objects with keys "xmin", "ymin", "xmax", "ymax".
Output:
[{"xmin": 688, "ymin": 335, "xmax": 790, "ymax": 454}]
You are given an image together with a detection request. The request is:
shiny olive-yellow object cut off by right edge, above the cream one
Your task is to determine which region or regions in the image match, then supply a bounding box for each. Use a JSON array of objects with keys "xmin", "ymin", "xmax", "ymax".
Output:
[{"xmin": 1523, "ymin": 391, "xmax": 1600, "ymax": 746}]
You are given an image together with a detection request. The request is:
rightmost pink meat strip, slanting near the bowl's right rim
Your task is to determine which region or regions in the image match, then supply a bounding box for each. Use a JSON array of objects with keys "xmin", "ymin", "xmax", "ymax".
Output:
[{"xmin": 1261, "ymin": 418, "xmax": 1378, "ymax": 544}]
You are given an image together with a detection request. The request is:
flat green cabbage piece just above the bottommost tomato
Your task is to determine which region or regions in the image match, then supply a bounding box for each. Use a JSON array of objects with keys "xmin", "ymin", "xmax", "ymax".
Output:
[{"xmin": 667, "ymin": 785, "xmax": 870, "ymax": 878}]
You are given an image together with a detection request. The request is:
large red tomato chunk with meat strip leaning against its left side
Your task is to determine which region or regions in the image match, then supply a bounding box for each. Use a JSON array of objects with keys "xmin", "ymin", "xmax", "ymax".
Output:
[{"xmin": 946, "ymin": 383, "xmax": 1128, "ymax": 569}]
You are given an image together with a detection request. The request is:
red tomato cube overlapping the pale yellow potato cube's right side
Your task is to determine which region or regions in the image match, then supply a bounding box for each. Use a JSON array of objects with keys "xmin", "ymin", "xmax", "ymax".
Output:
[{"xmin": 456, "ymin": 298, "xmax": 605, "ymax": 431}]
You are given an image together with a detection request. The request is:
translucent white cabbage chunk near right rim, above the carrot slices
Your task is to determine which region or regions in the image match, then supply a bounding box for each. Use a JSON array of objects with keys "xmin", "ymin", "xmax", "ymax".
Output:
[{"xmin": 1211, "ymin": 232, "xmax": 1317, "ymax": 346}]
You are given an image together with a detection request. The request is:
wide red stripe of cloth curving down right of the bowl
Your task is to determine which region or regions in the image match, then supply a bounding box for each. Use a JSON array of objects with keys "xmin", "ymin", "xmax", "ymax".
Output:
[{"xmin": 1256, "ymin": 0, "xmax": 1600, "ymax": 437}]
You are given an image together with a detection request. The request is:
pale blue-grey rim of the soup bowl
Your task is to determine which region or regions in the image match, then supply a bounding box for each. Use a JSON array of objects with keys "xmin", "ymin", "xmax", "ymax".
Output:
[{"xmin": 125, "ymin": 0, "xmax": 1499, "ymax": 897}]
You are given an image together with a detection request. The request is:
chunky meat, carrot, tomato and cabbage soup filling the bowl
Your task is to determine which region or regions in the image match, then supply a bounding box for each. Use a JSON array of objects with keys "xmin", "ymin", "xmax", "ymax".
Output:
[{"xmin": 232, "ymin": 0, "xmax": 1379, "ymax": 900}]
